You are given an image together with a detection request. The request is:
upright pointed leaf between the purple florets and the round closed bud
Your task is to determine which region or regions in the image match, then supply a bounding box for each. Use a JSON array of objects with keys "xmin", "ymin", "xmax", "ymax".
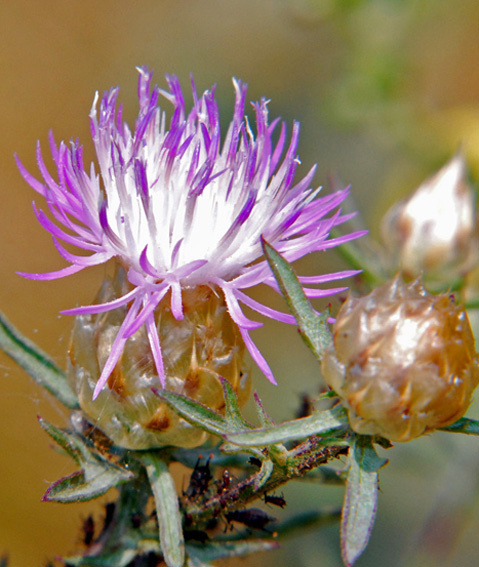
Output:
[{"xmin": 261, "ymin": 238, "xmax": 332, "ymax": 360}]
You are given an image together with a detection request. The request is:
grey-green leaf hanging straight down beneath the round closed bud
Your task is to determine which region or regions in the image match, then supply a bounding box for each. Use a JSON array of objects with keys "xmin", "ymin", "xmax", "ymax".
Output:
[{"xmin": 341, "ymin": 436, "xmax": 387, "ymax": 567}]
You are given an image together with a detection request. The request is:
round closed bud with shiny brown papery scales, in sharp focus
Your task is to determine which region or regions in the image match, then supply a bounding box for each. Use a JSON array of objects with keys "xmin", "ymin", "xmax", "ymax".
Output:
[{"xmin": 322, "ymin": 278, "xmax": 479, "ymax": 441}]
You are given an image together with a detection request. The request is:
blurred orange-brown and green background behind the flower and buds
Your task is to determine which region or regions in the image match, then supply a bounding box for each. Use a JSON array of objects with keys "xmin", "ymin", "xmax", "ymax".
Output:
[{"xmin": 0, "ymin": 0, "xmax": 479, "ymax": 567}]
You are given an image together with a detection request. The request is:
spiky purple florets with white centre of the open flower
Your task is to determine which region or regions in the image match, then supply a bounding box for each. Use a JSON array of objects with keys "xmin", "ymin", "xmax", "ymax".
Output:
[{"xmin": 18, "ymin": 69, "xmax": 359, "ymax": 397}]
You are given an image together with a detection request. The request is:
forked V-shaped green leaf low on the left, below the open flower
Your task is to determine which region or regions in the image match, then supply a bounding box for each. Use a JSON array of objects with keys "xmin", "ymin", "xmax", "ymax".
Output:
[{"xmin": 38, "ymin": 417, "xmax": 133, "ymax": 503}]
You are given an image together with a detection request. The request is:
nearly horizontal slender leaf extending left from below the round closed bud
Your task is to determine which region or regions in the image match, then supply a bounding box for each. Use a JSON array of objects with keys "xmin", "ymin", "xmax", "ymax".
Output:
[{"xmin": 226, "ymin": 408, "xmax": 349, "ymax": 447}]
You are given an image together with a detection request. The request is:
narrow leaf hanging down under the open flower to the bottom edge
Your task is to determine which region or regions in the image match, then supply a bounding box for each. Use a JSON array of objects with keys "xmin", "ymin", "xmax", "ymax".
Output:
[{"xmin": 139, "ymin": 452, "xmax": 185, "ymax": 567}]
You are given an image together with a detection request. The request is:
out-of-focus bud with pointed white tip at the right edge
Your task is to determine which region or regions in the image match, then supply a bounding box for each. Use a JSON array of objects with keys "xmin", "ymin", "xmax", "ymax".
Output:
[{"xmin": 381, "ymin": 154, "xmax": 477, "ymax": 281}]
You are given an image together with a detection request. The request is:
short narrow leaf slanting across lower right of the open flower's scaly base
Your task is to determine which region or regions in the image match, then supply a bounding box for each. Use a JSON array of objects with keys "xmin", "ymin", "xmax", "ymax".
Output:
[{"xmin": 154, "ymin": 388, "xmax": 229, "ymax": 437}]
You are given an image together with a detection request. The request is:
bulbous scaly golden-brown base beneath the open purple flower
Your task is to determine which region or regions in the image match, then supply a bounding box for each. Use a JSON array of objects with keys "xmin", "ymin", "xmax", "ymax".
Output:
[{"xmin": 69, "ymin": 269, "xmax": 255, "ymax": 449}]
